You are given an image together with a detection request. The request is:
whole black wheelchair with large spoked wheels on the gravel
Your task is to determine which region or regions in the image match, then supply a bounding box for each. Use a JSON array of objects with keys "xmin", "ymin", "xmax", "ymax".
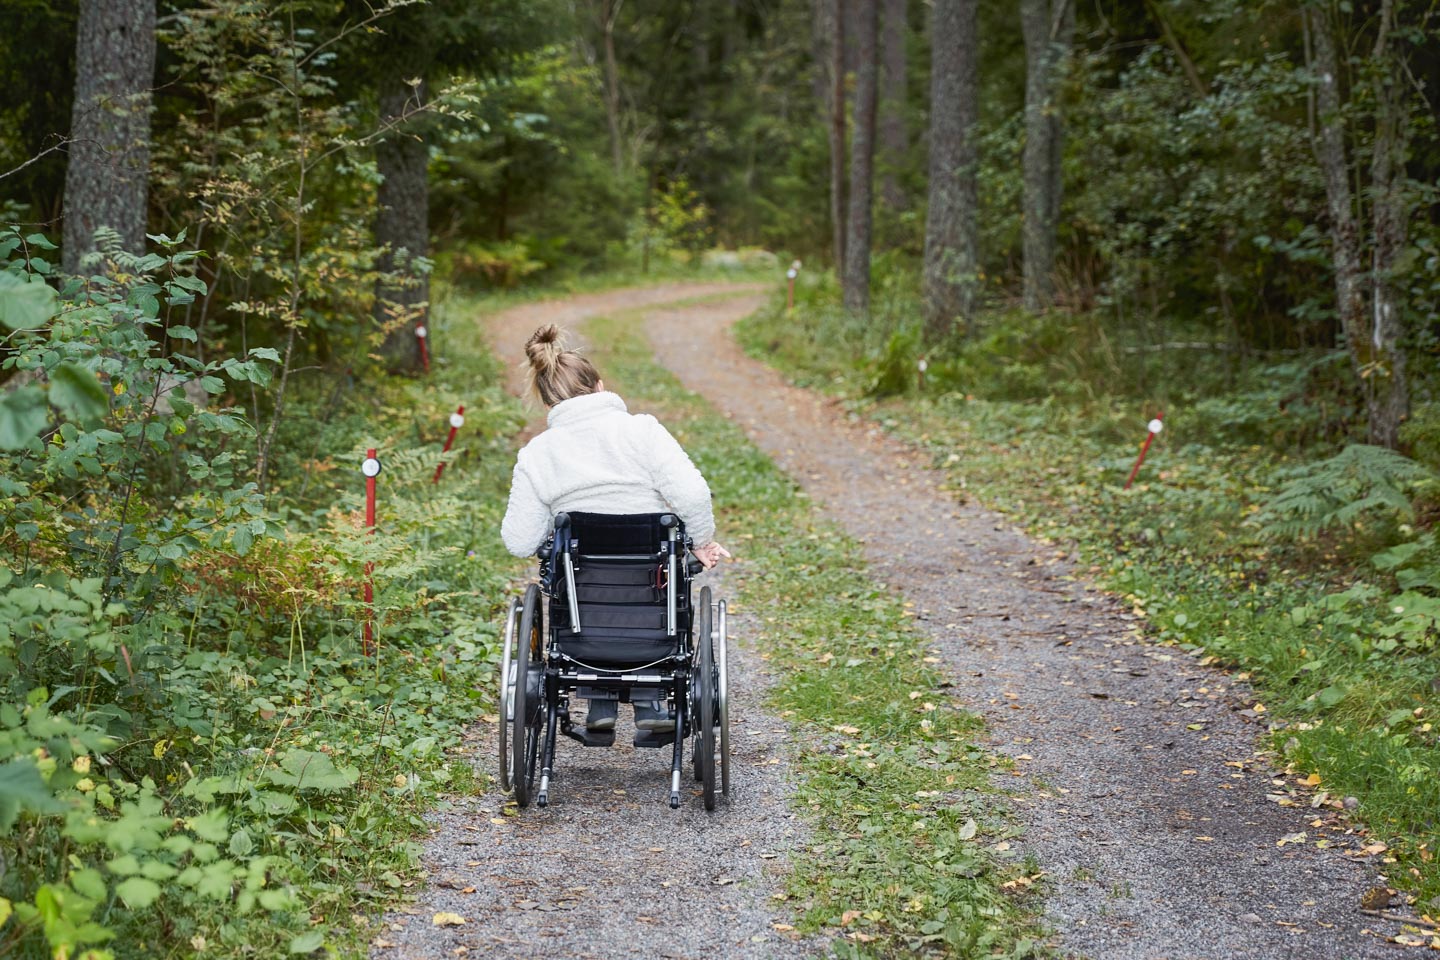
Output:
[{"xmin": 498, "ymin": 512, "xmax": 730, "ymax": 810}]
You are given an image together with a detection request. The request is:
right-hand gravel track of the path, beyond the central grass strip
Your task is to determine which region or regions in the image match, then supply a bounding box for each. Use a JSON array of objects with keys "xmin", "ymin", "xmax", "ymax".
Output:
[{"xmin": 649, "ymin": 305, "xmax": 1398, "ymax": 960}]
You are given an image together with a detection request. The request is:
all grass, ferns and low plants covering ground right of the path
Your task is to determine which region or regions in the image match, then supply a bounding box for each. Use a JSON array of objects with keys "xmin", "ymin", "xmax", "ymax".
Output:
[{"xmin": 739, "ymin": 272, "xmax": 1440, "ymax": 917}]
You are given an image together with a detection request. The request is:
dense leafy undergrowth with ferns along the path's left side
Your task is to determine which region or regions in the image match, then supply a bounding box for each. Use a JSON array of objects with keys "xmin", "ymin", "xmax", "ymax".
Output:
[{"xmin": 0, "ymin": 254, "xmax": 523, "ymax": 960}]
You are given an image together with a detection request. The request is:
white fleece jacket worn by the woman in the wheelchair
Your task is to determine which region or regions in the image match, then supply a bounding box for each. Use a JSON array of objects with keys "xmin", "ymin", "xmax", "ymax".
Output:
[{"xmin": 500, "ymin": 390, "xmax": 716, "ymax": 557}]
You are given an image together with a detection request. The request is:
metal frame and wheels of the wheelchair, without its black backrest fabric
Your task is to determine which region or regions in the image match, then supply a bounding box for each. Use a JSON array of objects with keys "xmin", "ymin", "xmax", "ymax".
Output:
[{"xmin": 500, "ymin": 514, "xmax": 730, "ymax": 810}]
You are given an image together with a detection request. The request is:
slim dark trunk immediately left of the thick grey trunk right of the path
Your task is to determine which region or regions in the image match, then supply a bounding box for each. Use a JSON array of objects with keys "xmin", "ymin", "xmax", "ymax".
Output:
[{"xmin": 845, "ymin": 0, "xmax": 880, "ymax": 315}]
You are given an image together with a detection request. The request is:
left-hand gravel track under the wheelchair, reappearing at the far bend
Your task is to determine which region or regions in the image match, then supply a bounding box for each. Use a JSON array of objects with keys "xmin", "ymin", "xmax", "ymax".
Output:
[{"xmin": 370, "ymin": 284, "xmax": 824, "ymax": 960}]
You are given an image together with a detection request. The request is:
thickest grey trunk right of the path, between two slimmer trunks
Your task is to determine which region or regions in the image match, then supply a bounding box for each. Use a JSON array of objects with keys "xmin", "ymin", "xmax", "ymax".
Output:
[{"xmin": 922, "ymin": 0, "xmax": 979, "ymax": 340}]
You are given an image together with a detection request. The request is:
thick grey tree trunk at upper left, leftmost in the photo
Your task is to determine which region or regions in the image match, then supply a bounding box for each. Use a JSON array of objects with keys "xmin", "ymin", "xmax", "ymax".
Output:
[{"xmin": 62, "ymin": 0, "xmax": 156, "ymax": 273}]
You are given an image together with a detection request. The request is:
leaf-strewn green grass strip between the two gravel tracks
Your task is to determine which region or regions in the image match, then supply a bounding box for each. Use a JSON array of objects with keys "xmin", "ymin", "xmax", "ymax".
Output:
[{"xmin": 589, "ymin": 308, "xmax": 1041, "ymax": 957}]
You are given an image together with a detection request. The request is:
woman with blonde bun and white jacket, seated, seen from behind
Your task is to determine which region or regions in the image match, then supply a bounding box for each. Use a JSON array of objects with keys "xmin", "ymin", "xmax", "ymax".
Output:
[{"xmin": 501, "ymin": 324, "xmax": 730, "ymax": 733}]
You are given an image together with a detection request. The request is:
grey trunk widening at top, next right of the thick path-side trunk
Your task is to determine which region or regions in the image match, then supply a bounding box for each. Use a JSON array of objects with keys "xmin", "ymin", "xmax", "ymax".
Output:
[{"xmin": 1020, "ymin": 0, "xmax": 1074, "ymax": 312}]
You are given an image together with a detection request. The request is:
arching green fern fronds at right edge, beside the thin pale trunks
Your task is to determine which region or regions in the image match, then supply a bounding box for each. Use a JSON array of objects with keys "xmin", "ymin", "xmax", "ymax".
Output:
[{"xmin": 1257, "ymin": 443, "xmax": 1436, "ymax": 540}]
